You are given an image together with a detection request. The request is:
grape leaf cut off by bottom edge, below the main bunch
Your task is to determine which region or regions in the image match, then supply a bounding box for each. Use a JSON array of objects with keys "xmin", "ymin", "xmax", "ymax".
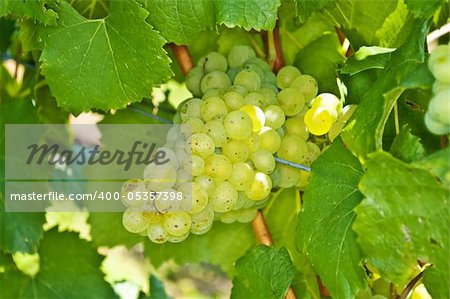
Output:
[{"xmin": 231, "ymin": 245, "xmax": 295, "ymax": 298}]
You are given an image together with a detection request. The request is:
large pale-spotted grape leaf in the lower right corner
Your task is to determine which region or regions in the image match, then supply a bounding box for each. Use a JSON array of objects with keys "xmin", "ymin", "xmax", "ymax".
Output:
[{"xmin": 353, "ymin": 152, "xmax": 450, "ymax": 298}]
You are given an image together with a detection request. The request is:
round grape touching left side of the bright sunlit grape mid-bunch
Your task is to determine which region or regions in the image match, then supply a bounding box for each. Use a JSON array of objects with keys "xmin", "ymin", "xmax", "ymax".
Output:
[{"xmin": 223, "ymin": 110, "xmax": 253, "ymax": 140}]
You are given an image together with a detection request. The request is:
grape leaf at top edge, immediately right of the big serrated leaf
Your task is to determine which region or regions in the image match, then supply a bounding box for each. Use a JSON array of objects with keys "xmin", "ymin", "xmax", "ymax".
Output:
[{"xmin": 142, "ymin": 0, "xmax": 215, "ymax": 45}]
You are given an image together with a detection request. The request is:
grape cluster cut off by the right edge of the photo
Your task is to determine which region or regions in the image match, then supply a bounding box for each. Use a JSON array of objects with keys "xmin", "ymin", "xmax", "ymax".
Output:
[{"xmin": 425, "ymin": 45, "xmax": 450, "ymax": 135}]
